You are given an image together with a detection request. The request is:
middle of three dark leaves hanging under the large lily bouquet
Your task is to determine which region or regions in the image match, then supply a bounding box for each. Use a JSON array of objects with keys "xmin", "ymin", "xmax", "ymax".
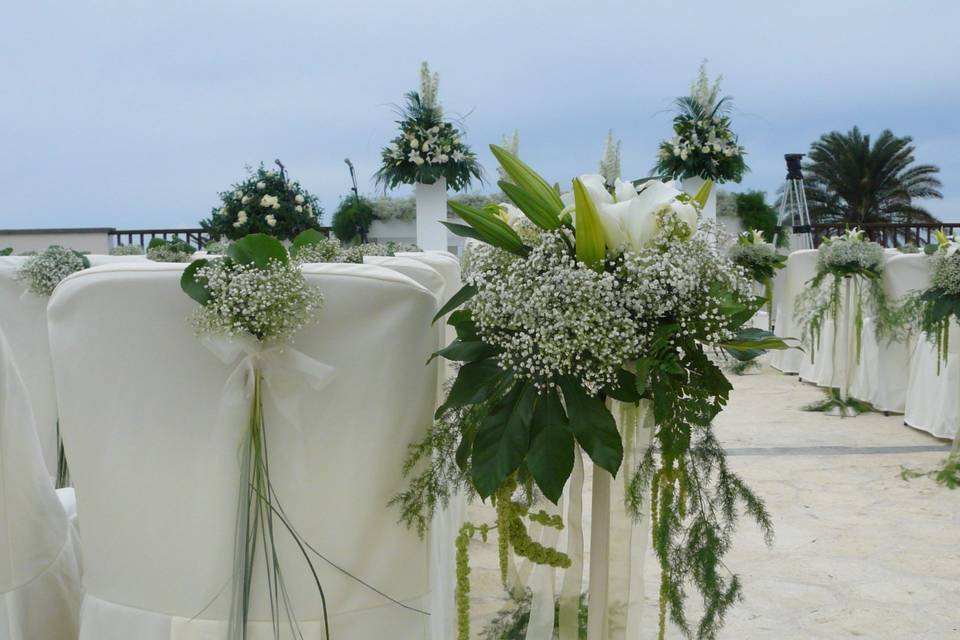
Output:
[{"xmin": 527, "ymin": 387, "xmax": 574, "ymax": 504}]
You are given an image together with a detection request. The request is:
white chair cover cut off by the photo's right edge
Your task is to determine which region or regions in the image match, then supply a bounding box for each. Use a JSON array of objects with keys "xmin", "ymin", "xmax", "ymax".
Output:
[{"xmin": 903, "ymin": 322, "xmax": 960, "ymax": 439}]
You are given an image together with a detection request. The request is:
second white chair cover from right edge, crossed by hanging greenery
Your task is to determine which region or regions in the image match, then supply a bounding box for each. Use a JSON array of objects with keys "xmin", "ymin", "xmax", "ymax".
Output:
[{"xmin": 850, "ymin": 252, "xmax": 932, "ymax": 413}]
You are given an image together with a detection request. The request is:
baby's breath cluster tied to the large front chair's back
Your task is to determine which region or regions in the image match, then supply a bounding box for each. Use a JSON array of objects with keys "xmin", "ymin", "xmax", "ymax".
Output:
[{"xmin": 191, "ymin": 260, "xmax": 323, "ymax": 341}]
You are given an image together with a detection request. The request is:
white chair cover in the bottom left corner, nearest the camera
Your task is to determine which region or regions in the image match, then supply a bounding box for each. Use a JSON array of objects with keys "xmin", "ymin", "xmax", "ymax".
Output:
[{"xmin": 0, "ymin": 331, "xmax": 80, "ymax": 640}]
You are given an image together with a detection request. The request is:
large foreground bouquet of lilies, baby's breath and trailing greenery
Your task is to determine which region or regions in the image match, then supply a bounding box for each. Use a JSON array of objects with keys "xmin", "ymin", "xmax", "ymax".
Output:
[{"xmin": 396, "ymin": 146, "xmax": 786, "ymax": 638}]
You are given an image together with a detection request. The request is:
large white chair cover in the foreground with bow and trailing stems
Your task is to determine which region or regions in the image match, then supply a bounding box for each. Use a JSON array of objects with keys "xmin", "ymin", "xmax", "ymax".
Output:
[{"xmin": 49, "ymin": 263, "xmax": 436, "ymax": 640}]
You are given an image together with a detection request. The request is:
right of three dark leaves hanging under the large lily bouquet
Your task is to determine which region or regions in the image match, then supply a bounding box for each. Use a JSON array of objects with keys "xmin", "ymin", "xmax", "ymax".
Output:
[{"xmin": 560, "ymin": 376, "xmax": 623, "ymax": 475}]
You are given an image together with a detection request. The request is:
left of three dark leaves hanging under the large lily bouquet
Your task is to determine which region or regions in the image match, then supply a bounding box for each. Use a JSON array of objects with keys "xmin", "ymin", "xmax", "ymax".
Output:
[{"xmin": 471, "ymin": 382, "xmax": 537, "ymax": 498}]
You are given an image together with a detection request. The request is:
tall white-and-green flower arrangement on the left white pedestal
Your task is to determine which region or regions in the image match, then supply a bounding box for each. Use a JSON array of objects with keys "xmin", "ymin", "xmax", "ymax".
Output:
[{"xmin": 376, "ymin": 62, "xmax": 483, "ymax": 191}]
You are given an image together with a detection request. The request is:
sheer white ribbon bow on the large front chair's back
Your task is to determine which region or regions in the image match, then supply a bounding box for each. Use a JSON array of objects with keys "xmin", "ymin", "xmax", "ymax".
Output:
[{"xmin": 201, "ymin": 335, "xmax": 336, "ymax": 431}]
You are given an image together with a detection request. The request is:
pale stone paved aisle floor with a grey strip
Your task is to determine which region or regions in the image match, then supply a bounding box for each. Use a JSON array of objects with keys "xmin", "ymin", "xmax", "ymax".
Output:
[{"xmin": 471, "ymin": 368, "xmax": 960, "ymax": 640}]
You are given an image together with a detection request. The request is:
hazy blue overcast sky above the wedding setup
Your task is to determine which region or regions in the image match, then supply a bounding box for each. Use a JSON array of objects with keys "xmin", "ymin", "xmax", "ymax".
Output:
[{"xmin": 0, "ymin": 0, "xmax": 960, "ymax": 228}]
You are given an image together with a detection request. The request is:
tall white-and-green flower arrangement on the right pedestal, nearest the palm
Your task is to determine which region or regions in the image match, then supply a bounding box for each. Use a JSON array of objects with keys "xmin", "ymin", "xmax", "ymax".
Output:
[{"xmin": 655, "ymin": 63, "xmax": 747, "ymax": 183}]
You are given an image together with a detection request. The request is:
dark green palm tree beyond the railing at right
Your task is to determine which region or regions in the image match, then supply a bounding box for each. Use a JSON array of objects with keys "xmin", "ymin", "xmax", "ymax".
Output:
[{"xmin": 804, "ymin": 127, "xmax": 943, "ymax": 225}]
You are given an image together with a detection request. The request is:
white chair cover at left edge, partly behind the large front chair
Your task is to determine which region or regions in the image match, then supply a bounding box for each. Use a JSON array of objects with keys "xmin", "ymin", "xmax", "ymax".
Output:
[{"xmin": 0, "ymin": 256, "xmax": 57, "ymax": 476}]
